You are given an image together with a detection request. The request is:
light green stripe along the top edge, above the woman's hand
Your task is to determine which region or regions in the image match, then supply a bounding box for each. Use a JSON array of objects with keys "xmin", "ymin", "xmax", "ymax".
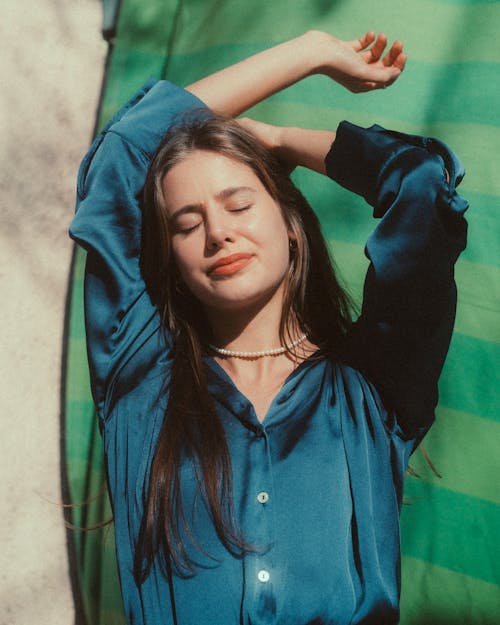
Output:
[{"xmin": 163, "ymin": 0, "xmax": 500, "ymax": 62}]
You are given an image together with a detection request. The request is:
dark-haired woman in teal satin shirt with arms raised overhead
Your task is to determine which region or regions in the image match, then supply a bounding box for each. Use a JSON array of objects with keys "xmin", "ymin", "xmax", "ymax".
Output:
[{"xmin": 71, "ymin": 32, "xmax": 467, "ymax": 625}]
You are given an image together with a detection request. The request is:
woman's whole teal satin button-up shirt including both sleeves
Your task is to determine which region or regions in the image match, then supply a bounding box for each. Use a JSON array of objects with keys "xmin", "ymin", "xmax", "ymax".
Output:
[{"xmin": 71, "ymin": 81, "xmax": 467, "ymax": 625}]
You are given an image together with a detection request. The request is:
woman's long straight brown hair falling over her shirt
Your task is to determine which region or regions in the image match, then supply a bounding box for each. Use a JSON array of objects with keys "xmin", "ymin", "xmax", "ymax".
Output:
[{"xmin": 135, "ymin": 114, "xmax": 351, "ymax": 583}]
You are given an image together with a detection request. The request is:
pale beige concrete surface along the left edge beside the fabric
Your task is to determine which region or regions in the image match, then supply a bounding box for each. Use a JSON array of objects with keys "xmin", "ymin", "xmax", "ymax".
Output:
[{"xmin": 0, "ymin": 0, "xmax": 106, "ymax": 625}]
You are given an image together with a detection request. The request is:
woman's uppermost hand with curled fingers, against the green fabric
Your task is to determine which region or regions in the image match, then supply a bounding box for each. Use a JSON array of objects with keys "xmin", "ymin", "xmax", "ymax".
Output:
[{"xmin": 304, "ymin": 30, "xmax": 406, "ymax": 93}]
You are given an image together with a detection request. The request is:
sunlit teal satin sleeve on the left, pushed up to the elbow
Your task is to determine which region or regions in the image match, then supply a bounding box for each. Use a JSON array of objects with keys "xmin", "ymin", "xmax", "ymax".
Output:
[{"xmin": 70, "ymin": 81, "xmax": 204, "ymax": 417}]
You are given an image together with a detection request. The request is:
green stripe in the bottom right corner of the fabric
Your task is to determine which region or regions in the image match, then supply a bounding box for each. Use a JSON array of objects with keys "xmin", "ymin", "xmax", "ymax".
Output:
[{"xmin": 401, "ymin": 546, "xmax": 500, "ymax": 625}]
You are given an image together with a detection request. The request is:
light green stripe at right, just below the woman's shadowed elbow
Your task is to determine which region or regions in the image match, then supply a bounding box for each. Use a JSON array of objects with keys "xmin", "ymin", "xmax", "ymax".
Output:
[{"xmin": 410, "ymin": 405, "xmax": 500, "ymax": 504}]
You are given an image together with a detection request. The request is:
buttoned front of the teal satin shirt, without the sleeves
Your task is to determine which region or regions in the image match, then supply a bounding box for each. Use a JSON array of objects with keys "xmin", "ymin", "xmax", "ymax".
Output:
[{"xmin": 106, "ymin": 360, "xmax": 412, "ymax": 625}]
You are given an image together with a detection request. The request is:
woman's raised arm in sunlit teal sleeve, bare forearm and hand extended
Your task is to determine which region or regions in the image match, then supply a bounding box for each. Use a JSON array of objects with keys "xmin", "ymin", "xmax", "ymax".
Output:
[{"xmin": 70, "ymin": 32, "xmax": 405, "ymax": 416}]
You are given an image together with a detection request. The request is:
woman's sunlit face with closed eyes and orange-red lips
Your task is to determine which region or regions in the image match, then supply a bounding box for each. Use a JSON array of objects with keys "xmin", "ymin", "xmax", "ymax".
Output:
[{"xmin": 163, "ymin": 150, "xmax": 293, "ymax": 311}]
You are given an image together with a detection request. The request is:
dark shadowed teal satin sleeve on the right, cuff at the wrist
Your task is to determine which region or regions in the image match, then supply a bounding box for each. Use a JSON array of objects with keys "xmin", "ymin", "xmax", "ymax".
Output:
[{"xmin": 326, "ymin": 122, "xmax": 468, "ymax": 439}]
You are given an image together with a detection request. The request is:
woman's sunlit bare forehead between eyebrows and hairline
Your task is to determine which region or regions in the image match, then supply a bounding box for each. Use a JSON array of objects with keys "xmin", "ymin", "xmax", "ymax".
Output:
[{"xmin": 162, "ymin": 150, "xmax": 267, "ymax": 212}]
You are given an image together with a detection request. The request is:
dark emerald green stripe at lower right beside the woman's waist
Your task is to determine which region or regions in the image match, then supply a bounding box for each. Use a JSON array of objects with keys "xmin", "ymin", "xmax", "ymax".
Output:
[{"xmin": 401, "ymin": 478, "xmax": 500, "ymax": 583}]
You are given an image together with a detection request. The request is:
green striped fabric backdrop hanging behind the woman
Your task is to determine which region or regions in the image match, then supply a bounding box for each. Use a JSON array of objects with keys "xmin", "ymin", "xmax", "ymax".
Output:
[{"xmin": 65, "ymin": 0, "xmax": 500, "ymax": 625}]
